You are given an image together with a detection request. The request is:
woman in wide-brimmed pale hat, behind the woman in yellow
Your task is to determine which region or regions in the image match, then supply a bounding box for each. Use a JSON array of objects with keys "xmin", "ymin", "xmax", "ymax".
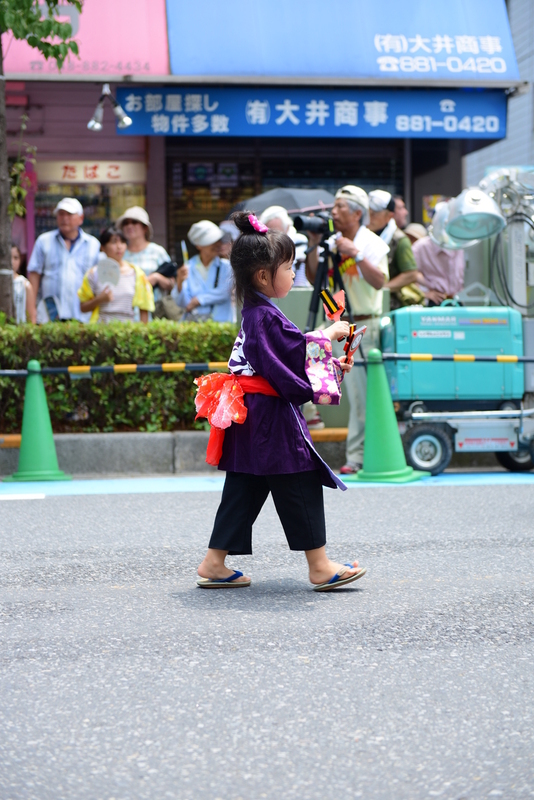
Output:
[{"xmin": 116, "ymin": 206, "xmax": 174, "ymax": 300}]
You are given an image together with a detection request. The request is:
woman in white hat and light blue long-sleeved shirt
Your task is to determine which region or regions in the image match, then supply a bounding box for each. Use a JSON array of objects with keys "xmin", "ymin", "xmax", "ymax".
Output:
[{"xmin": 172, "ymin": 219, "xmax": 235, "ymax": 322}]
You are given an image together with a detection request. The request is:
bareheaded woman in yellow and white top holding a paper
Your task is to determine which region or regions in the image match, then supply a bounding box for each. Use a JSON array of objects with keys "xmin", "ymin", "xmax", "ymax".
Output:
[{"xmin": 78, "ymin": 228, "xmax": 154, "ymax": 322}]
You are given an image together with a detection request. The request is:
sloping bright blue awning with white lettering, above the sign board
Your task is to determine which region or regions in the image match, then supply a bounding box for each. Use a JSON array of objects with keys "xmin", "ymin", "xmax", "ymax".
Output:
[{"xmin": 167, "ymin": 0, "xmax": 519, "ymax": 88}]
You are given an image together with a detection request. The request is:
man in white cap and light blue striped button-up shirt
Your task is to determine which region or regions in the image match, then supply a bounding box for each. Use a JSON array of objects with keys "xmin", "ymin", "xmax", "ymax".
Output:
[{"xmin": 28, "ymin": 197, "xmax": 100, "ymax": 322}]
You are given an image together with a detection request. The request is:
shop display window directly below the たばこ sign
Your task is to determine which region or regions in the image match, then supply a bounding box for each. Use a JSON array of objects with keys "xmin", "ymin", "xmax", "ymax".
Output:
[{"xmin": 35, "ymin": 183, "xmax": 145, "ymax": 237}]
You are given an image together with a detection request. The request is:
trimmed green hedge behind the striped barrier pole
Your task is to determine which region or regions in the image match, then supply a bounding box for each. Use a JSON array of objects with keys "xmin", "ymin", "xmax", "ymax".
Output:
[{"xmin": 0, "ymin": 320, "xmax": 236, "ymax": 433}]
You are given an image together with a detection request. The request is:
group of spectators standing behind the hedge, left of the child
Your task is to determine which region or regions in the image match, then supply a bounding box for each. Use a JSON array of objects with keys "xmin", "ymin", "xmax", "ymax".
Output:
[{"xmin": 15, "ymin": 197, "xmax": 236, "ymax": 323}]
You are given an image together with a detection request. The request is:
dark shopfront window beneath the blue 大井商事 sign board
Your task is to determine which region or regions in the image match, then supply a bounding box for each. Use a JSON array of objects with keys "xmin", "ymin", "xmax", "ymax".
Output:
[{"xmin": 167, "ymin": 138, "xmax": 404, "ymax": 257}]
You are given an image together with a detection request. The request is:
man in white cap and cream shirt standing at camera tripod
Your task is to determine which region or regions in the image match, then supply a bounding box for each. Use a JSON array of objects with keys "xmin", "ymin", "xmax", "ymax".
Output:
[{"xmin": 306, "ymin": 186, "xmax": 389, "ymax": 475}]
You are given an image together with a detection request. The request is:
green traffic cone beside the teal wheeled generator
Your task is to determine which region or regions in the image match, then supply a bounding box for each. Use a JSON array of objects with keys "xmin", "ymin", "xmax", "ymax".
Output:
[{"xmin": 343, "ymin": 349, "xmax": 430, "ymax": 483}]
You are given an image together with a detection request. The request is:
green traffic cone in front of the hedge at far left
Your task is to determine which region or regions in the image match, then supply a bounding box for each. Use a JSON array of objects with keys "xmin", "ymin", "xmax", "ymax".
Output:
[{"xmin": 4, "ymin": 360, "xmax": 71, "ymax": 481}]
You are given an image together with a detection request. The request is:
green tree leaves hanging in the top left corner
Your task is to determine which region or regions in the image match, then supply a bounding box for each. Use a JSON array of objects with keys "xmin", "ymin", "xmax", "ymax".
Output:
[{"xmin": 0, "ymin": 0, "xmax": 82, "ymax": 69}]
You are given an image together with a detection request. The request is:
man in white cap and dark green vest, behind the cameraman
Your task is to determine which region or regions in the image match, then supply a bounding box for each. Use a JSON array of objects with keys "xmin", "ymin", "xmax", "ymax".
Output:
[{"xmin": 369, "ymin": 189, "xmax": 422, "ymax": 309}]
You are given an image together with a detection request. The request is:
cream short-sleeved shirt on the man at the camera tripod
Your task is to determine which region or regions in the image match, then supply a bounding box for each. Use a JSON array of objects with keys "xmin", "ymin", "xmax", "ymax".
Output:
[{"xmin": 328, "ymin": 225, "xmax": 389, "ymax": 317}]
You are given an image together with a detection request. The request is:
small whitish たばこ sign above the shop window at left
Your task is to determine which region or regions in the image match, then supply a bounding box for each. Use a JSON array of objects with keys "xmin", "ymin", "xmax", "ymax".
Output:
[{"xmin": 36, "ymin": 160, "xmax": 146, "ymax": 183}]
